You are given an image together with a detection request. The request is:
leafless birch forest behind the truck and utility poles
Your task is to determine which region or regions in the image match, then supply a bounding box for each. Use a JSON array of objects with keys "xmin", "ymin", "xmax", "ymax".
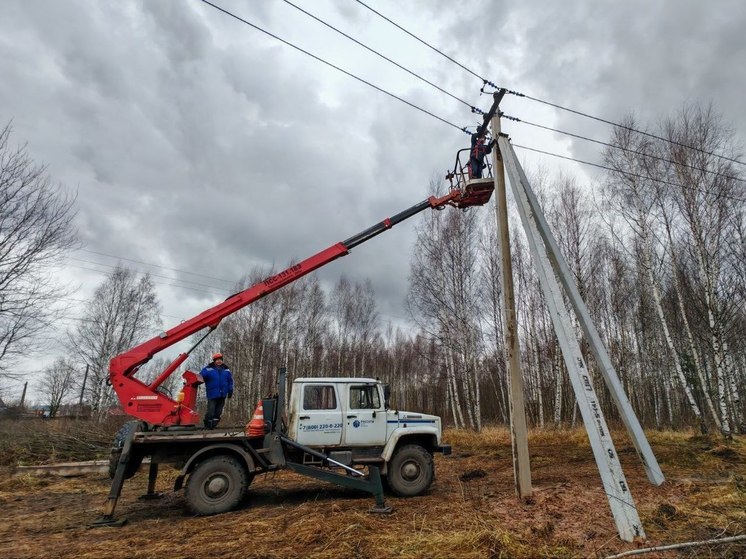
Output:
[{"xmin": 0, "ymin": 105, "xmax": 746, "ymax": 435}]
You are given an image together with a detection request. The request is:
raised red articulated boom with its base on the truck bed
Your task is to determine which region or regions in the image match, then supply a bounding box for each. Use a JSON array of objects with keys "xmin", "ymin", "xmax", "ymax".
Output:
[{"xmin": 109, "ymin": 188, "xmax": 492, "ymax": 426}]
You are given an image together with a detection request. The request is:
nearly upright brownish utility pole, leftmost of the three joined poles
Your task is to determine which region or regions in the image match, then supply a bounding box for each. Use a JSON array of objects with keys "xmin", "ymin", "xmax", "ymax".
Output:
[{"xmin": 492, "ymin": 110, "xmax": 533, "ymax": 499}]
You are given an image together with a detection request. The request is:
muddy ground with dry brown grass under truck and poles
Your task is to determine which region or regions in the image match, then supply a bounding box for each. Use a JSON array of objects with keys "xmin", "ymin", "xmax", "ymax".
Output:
[{"xmin": 0, "ymin": 428, "xmax": 746, "ymax": 559}]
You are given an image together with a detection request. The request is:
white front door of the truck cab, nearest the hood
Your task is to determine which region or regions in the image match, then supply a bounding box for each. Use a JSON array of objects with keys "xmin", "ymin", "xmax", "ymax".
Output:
[{"xmin": 345, "ymin": 384, "xmax": 386, "ymax": 446}]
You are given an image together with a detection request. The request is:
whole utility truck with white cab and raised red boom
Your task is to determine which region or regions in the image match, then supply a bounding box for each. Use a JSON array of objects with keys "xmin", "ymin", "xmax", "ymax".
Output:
[{"xmin": 94, "ymin": 181, "xmax": 494, "ymax": 526}]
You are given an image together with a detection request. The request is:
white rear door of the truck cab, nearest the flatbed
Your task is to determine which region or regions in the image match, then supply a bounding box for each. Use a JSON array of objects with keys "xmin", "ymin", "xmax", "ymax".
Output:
[{"xmin": 296, "ymin": 383, "xmax": 342, "ymax": 446}]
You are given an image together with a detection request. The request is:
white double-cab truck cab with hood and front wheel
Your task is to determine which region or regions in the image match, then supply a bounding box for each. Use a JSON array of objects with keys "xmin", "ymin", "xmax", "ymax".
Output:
[{"xmin": 288, "ymin": 377, "xmax": 451, "ymax": 497}]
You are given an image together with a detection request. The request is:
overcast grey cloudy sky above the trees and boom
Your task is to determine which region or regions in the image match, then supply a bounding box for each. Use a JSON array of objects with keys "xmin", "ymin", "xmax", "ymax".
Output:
[{"xmin": 0, "ymin": 0, "xmax": 746, "ymax": 396}]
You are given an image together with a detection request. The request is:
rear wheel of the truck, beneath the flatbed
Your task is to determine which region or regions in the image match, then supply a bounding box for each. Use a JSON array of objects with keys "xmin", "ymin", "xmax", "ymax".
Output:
[{"xmin": 184, "ymin": 455, "xmax": 249, "ymax": 516}]
